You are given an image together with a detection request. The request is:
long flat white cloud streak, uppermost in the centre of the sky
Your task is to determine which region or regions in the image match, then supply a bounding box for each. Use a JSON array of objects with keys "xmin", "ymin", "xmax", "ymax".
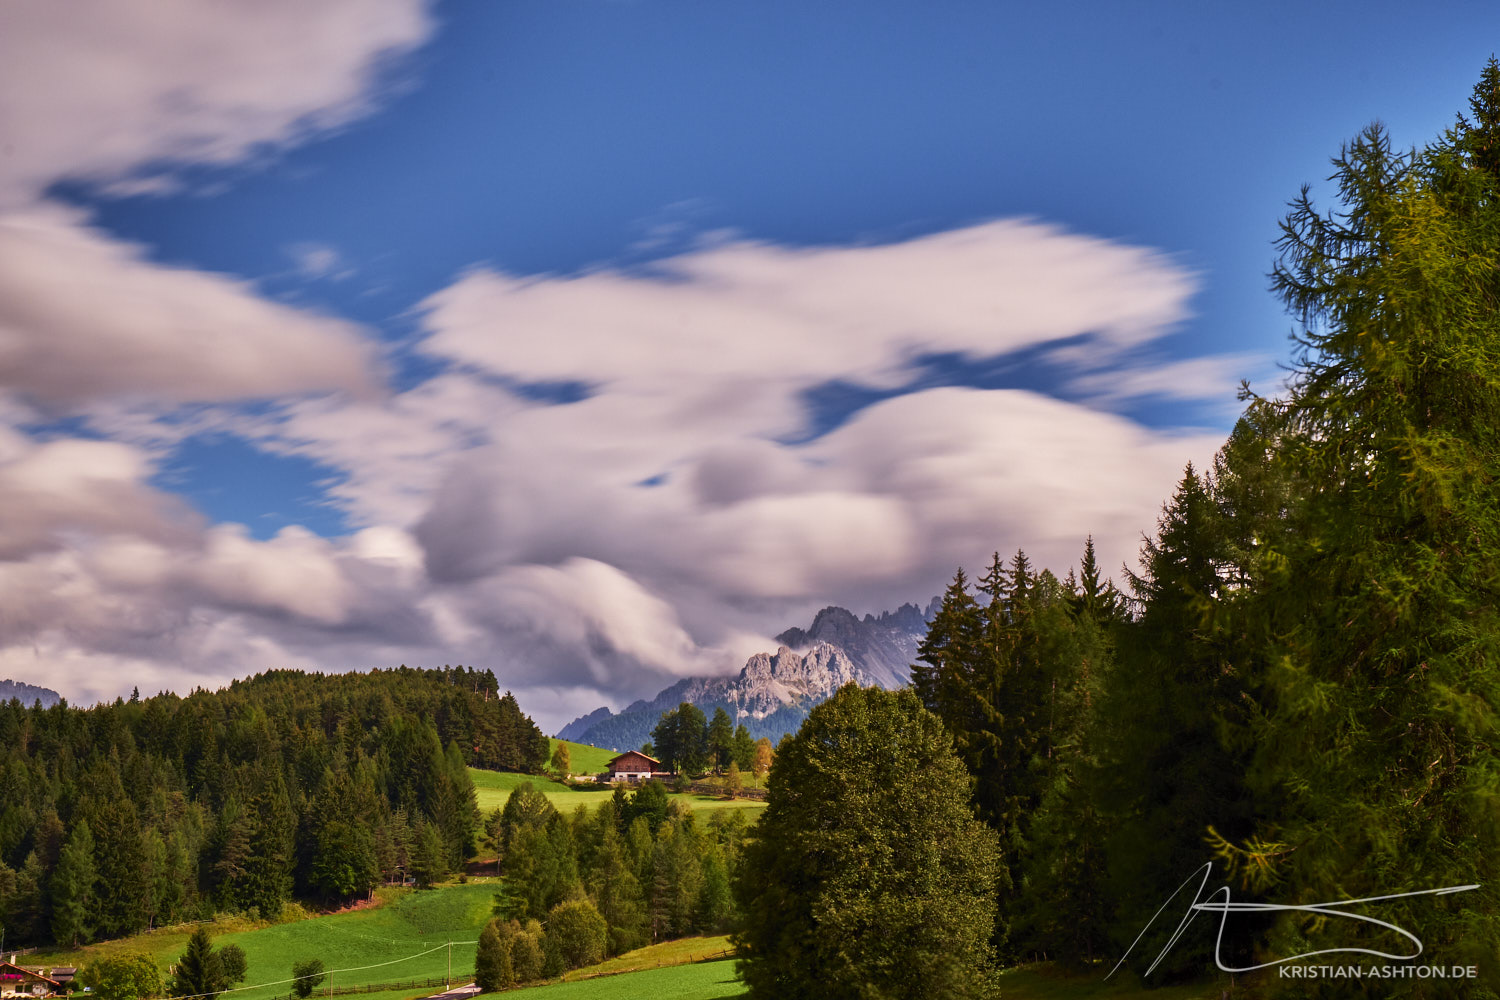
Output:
[{"xmin": 425, "ymin": 220, "xmax": 1193, "ymax": 395}]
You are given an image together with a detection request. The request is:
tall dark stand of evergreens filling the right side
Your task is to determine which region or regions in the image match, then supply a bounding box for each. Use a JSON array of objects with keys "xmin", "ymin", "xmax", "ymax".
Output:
[{"xmin": 914, "ymin": 60, "xmax": 1500, "ymax": 996}]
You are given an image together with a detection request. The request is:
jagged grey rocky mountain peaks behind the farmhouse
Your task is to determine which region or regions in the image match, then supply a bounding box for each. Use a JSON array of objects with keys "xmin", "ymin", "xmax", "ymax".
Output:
[{"xmin": 558, "ymin": 598, "xmax": 941, "ymax": 750}]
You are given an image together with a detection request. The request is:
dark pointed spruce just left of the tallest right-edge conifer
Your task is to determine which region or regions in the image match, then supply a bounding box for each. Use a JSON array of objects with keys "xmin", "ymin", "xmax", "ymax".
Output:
[{"xmin": 1100, "ymin": 465, "xmax": 1254, "ymax": 979}]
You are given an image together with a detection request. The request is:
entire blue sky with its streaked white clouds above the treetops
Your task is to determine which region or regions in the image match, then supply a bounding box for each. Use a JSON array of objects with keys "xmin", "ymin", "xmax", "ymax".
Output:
[{"xmin": 0, "ymin": 0, "xmax": 1500, "ymax": 723}]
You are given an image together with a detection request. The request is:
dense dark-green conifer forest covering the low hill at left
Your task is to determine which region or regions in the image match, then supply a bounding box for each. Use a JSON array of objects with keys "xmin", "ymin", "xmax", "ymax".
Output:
[{"xmin": 0, "ymin": 667, "xmax": 549, "ymax": 945}]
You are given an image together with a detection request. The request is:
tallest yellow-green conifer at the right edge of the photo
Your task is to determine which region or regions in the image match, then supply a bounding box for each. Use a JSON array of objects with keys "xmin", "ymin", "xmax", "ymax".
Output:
[{"xmin": 1224, "ymin": 60, "xmax": 1500, "ymax": 996}]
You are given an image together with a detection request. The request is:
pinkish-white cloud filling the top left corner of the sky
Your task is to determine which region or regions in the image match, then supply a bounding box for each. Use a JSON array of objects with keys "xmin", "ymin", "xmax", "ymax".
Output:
[{"xmin": 0, "ymin": 0, "xmax": 434, "ymax": 208}]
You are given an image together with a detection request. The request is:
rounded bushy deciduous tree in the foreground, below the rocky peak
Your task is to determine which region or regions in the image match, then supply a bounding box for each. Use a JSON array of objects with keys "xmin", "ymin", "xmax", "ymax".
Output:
[{"xmin": 734, "ymin": 685, "xmax": 999, "ymax": 1000}]
